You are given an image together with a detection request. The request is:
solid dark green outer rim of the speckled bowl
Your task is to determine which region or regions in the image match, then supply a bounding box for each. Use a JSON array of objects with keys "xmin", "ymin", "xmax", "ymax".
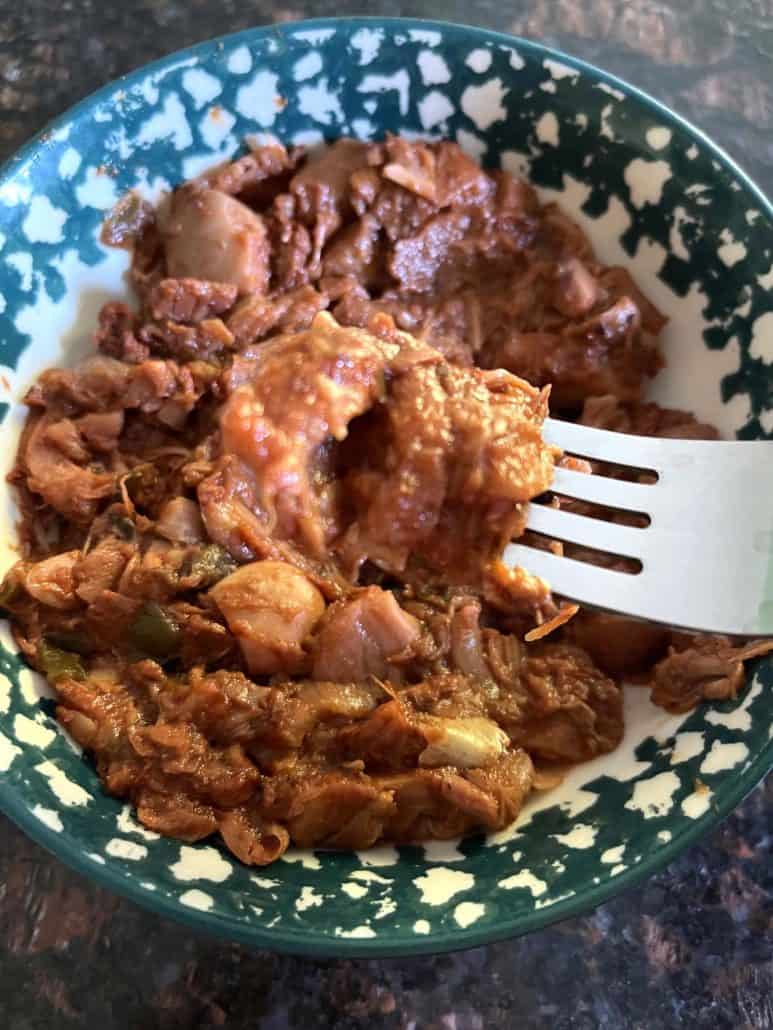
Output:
[{"xmin": 0, "ymin": 15, "xmax": 773, "ymax": 958}]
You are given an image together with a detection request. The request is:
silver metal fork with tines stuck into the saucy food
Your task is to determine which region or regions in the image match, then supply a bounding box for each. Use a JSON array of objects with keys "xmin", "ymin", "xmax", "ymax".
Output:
[{"xmin": 503, "ymin": 418, "xmax": 773, "ymax": 636}]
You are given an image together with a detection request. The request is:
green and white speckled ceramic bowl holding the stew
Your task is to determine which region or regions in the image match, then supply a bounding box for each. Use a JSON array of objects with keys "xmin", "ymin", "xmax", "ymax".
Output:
[{"xmin": 0, "ymin": 19, "xmax": 773, "ymax": 955}]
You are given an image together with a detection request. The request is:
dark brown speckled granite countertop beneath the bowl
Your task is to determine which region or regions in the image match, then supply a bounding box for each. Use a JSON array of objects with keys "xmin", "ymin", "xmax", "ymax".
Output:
[{"xmin": 0, "ymin": 0, "xmax": 773, "ymax": 1030}]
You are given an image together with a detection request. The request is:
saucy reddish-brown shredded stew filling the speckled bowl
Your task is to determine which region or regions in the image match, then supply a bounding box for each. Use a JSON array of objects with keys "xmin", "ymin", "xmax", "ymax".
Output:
[{"xmin": 0, "ymin": 137, "xmax": 771, "ymax": 864}]
